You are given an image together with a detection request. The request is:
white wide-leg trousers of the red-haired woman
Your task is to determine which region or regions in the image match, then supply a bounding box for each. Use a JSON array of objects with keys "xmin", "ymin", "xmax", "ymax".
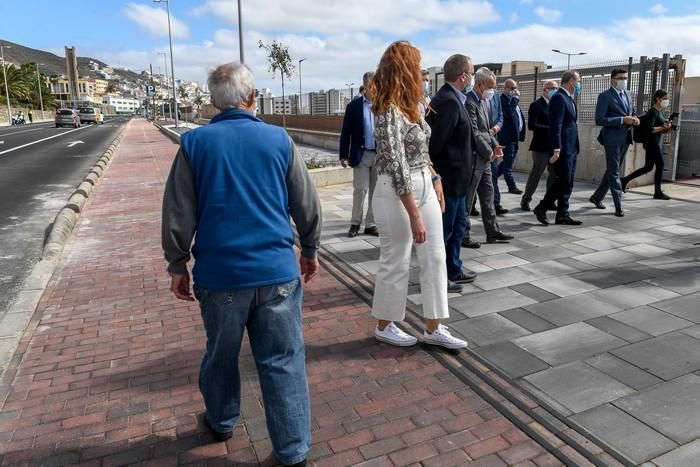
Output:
[{"xmin": 372, "ymin": 168, "xmax": 449, "ymax": 321}]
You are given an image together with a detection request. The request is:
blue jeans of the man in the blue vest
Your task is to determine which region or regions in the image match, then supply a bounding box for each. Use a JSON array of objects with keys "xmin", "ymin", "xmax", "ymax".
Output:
[{"xmin": 195, "ymin": 279, "xmax": 311, "ymax": 464}]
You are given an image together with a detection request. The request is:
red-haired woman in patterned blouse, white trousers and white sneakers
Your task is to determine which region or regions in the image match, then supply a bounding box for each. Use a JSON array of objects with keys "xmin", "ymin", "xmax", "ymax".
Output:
[{"xmin": 372, "ymin": 41, "xmax": 467, "ymax": 349}]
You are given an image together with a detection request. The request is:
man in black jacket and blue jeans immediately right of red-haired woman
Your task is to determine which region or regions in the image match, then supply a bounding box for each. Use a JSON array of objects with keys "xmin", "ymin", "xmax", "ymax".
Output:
[{"xmin": 427, "ymin": 54, "xmax": 476, "ymax": 287}]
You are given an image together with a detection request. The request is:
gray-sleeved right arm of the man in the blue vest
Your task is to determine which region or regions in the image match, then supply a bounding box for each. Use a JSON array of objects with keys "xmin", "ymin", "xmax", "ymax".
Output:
[{"xmin": 287, "ymin": 138, "xmax": 323, "ymax": 282}]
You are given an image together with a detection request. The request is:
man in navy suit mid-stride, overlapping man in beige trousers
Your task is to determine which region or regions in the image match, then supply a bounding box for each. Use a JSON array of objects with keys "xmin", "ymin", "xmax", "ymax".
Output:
[{"xmin": 533, "ymin": 70, "xmax": 581, "ymax": 229}]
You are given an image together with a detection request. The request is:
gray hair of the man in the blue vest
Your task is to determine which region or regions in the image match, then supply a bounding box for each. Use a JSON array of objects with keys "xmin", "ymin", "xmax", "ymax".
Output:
[{"xmin": 207, "ymin": 63, "xmax": 255, "ymax": 111}]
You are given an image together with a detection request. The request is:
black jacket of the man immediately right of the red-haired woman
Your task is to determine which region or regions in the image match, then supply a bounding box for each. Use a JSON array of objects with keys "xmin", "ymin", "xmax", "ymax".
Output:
[{"xmin": 427, "ymin": 83, "xmax": 474, "ymax": 198}]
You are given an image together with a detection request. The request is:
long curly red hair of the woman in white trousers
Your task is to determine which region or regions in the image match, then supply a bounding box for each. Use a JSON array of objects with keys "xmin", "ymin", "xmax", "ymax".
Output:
[{"xmin": 372, "ymin": 41, "xmax": 424, "ymax": 123}]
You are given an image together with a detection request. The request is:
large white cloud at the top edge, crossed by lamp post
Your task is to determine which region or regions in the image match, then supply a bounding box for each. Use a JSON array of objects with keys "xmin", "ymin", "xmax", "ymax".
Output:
[{"xmin": 194, "ymin": 0, "xmax": 499, "ymax": 37}]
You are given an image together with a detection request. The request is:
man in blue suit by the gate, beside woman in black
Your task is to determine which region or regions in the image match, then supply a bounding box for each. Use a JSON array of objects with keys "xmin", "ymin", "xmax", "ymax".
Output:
[{"xmin": 589, "ymin": 68, "xmax": 639, "ymax": 217}]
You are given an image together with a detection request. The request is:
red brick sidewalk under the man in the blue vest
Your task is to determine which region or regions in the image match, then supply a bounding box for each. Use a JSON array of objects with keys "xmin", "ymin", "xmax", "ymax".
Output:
[{"xmin": 0, "ymin": 120, "xmax": 560, "ymax": 466}]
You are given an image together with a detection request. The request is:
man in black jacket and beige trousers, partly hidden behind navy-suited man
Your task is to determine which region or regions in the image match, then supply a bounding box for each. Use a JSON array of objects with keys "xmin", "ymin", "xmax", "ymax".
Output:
[{"xmin": 520, "ymin": 80, "xmax": 559, "ymax": 211}]
